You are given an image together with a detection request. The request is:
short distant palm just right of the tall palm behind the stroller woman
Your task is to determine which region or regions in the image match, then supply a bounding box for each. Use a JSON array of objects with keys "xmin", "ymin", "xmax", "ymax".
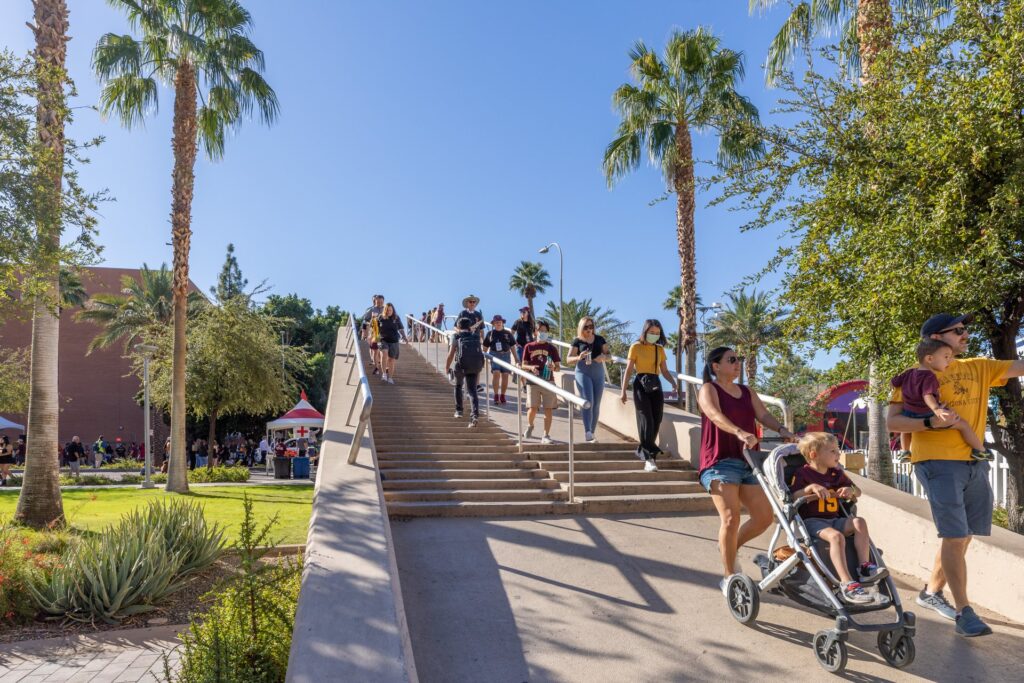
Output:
[{"xmin": 708, "ymin": 290, "xmax": 785, "ymax": 387}]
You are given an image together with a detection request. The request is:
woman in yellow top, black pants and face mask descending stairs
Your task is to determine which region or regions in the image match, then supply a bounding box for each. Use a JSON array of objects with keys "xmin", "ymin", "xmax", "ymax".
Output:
[{"xmin": 620, "ymin": 318, "xmax": 679, "ymax": 472}]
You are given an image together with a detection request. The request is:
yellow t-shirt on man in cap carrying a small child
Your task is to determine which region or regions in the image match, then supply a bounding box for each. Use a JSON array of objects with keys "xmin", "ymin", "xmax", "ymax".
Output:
[{"xmin": 889, "ymin": 358, "xmax": 1013, "ymax": 463}]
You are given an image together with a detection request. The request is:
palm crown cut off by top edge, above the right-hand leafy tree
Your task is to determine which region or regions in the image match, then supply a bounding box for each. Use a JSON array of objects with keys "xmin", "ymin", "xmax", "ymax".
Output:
[{"xmin": 750, "ymin": 0, "xmax": 953, "ymax": 84}]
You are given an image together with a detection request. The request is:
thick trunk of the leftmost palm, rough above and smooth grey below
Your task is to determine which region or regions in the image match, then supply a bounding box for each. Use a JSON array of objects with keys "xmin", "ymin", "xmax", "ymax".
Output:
[{"xmin": 14, "ymin": 0, "xmax": 68, "ymax": 528}]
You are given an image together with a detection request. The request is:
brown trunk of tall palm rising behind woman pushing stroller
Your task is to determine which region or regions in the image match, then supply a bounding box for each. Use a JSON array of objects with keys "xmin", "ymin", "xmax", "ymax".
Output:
[{"xmin": 674, "ymin": 122, "xmax": 697, "ymax": 413}]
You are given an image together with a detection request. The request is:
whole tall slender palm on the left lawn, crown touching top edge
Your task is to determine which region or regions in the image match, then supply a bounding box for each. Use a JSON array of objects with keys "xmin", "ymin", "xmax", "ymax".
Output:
[{"xmin": 92, "ymin": 0, "xmax": 279, "ymax": 493}]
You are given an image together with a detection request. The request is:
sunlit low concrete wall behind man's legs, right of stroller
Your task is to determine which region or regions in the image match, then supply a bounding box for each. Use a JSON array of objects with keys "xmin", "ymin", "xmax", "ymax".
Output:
[{"xmin": 851, "ymin": 474, "xmax": 1024, "ymax": 623}]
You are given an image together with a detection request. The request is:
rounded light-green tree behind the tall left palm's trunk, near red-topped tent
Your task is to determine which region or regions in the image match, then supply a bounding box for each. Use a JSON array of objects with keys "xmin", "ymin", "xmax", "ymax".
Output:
[{"xmin": 144, "ymin": 298, "xmax": 305, "ymax": 466}]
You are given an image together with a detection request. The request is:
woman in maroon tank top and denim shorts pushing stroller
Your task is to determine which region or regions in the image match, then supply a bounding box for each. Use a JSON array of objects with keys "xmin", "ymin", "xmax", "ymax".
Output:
[{"xmin": 697, "ymin": 346, "xmax": 794, "ymax": 593}]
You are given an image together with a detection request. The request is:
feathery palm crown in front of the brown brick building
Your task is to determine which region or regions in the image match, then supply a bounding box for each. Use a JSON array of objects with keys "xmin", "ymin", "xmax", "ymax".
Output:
[{"xmin": 75, "ymin": 263, "xmax": 206, "ymax": 352}]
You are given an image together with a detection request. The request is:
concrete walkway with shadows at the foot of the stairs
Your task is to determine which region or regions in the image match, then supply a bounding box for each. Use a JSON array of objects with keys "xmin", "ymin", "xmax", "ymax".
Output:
[{"xmin": 392, "ymin": 515, "xmax": 1024, "ymax": 683}]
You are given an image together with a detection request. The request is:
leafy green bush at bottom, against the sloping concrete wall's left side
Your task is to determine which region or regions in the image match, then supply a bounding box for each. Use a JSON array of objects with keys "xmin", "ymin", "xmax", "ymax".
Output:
[{"xmin": 164, "ymin": 496, "xmax": 302, "ymax": 683}]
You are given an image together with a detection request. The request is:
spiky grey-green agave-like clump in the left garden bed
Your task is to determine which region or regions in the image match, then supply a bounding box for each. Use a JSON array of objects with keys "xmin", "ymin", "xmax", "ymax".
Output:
[{"xmin": 30, "ymin": 501, "xmax": 223, "ymax": 624}]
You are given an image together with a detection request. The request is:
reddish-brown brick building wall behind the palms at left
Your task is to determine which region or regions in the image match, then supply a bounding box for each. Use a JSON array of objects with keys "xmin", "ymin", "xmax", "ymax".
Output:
[{"xmin": 0, "ymin": 268, "xmax": 192, "ymax": 454}]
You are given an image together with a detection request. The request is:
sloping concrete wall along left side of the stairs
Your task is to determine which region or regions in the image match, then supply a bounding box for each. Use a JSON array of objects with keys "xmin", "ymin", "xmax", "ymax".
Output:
[{"xmin": 287, "ymin": 328, "xmax": 418, "ymax": 683}]
